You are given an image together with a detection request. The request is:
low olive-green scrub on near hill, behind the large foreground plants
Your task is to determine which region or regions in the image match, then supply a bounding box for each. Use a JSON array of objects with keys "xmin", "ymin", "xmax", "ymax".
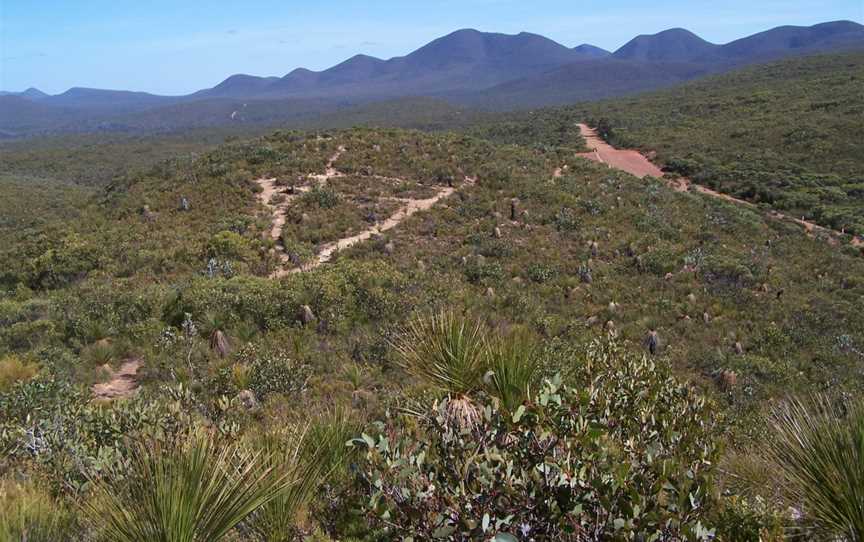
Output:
[{"xmin": 0, "ymin": 120, "xmax": 864, "ymax": 539}]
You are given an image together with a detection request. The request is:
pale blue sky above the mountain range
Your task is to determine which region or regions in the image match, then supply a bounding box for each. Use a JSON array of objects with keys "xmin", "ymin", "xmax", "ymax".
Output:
[{"xmin": 0, "ymin": 0, "xmax": 864, "ymax": 94}]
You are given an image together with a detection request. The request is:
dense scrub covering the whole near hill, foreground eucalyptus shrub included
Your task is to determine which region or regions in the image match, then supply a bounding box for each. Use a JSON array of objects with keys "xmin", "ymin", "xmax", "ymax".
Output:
[{"xmin": 0, "ymin": 109, "xmax": 864, "ymax": 540}]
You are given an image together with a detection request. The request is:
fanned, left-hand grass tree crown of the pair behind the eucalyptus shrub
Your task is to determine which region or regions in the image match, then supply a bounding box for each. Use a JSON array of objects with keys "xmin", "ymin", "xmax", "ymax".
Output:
[{"xmin": 393, "ymin": 311, "xmax": 487, "ymax": 395}]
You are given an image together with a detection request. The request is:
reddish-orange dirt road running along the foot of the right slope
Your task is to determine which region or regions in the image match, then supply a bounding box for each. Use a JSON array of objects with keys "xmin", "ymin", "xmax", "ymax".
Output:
[{"xmin": 577, "ymin": 124, "xmax": 864, "ymax": 247}]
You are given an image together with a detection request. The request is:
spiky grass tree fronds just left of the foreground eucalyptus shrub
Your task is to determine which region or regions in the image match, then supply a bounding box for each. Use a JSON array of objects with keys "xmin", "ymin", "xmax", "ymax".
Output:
[{"xmin": 248, "ymin": 411, "xmax": 358, "ymax": 542}]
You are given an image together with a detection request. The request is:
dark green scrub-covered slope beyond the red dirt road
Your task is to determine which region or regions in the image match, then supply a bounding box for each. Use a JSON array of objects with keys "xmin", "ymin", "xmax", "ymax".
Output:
[{"xmin": 570, "ymin": 53, "xmax": 864, "ymax": 234}]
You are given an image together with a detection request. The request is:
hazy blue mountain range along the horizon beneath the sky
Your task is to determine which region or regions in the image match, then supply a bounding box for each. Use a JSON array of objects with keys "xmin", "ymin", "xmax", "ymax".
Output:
[{"xmin": 0, "ymin": 21, "xmax": 864, "ymax": 135}]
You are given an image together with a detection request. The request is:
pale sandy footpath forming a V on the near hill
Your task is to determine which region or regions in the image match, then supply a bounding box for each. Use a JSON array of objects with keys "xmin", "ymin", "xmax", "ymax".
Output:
[{"xmin": 255, "ymin": 147, "xmax": 466, "ymax": 278}]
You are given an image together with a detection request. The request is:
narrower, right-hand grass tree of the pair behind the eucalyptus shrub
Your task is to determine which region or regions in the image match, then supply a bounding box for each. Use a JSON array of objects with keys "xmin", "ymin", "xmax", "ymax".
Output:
[{"xmin": 485, "ymin": 332, "xmax": 542, "ymax": 412}]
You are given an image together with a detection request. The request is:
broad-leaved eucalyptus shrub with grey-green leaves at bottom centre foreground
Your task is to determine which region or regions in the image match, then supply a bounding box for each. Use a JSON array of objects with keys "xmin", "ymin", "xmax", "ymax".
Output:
[{"xmin": 353, "ymin": 344, "xmax": 718, "ymax": 540}]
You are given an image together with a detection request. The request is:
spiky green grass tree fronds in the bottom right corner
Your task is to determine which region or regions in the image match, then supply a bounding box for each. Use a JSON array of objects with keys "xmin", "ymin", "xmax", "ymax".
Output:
[{"xmin": 769, "ymin": 396, "xmax": 864, "ymax": 542}]
